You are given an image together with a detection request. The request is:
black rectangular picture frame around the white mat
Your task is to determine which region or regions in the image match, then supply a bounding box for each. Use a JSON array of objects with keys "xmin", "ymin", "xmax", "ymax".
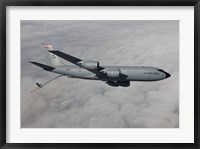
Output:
[{"xmin": 0, "ymin": 0, "xmax": 200, "ymax": 149}]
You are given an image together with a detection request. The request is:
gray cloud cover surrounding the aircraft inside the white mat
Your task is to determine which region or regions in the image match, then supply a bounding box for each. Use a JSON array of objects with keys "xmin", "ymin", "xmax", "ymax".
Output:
[{"xmin": 20, "ymin": 20, "xmax": 179, "ymax": 128}]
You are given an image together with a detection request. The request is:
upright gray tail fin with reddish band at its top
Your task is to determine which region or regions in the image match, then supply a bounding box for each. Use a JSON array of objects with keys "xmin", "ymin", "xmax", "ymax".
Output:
[{"xmin": 42, "ymin": 43, "xmax": 64, "ymax": 67}]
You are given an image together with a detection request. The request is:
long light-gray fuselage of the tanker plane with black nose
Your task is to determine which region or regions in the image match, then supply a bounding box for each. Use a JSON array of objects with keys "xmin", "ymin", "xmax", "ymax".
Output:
[{"xmin": 52, "ymin": 66, "xmax": 170, "ymax": 81}]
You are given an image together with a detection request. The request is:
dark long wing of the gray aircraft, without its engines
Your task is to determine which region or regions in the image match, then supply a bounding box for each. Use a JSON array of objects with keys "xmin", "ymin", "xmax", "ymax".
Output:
[{"xmin": 49, "ymin": 50, "xmax": 104, "ymax": 74}]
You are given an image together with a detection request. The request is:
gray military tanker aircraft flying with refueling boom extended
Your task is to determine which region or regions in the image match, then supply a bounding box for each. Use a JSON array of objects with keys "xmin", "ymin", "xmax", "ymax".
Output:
[{"xmin": 30, "ymin": 44, "xmax": 170, "ymax": 88}]
